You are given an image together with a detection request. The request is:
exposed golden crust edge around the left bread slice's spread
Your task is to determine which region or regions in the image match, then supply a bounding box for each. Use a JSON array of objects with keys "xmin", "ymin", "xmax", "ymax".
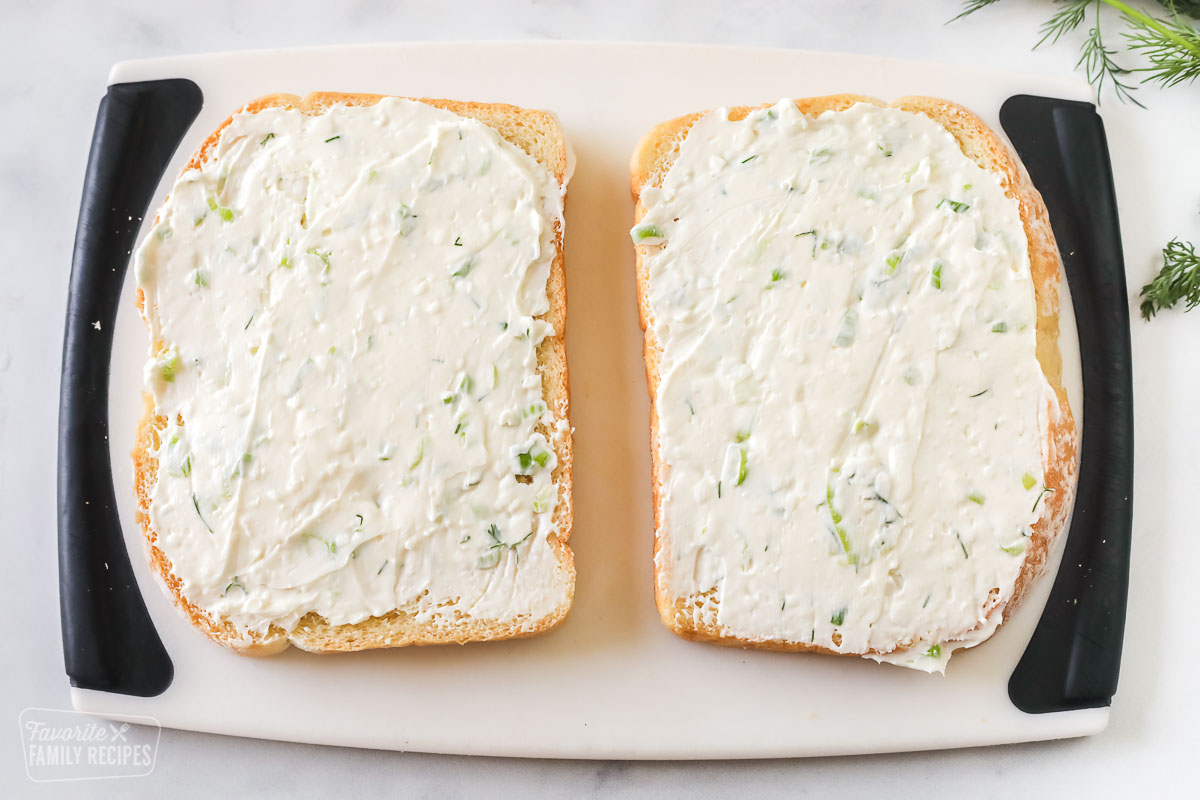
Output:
[{"xmin": 131, "ymin": 91, "xmax": 575, "ymax": 656}]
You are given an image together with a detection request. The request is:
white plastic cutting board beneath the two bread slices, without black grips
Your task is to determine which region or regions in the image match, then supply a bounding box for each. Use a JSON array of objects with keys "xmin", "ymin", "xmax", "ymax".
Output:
[{"xmin": 72, "ymin": 42, "xmax": 1109, "ymax": 758}]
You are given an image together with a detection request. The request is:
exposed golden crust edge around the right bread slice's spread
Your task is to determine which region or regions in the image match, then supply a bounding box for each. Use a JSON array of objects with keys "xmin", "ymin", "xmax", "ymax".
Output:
[{"xmin": 629, "ymin": 95, "xmax": 1079, "ymax": 656}]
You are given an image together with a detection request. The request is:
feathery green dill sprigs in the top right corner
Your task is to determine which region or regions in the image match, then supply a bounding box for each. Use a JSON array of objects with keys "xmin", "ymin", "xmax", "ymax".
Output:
[{"xmin": 950, "ymin": 0, "xmax": 1200, "ymax": 106}]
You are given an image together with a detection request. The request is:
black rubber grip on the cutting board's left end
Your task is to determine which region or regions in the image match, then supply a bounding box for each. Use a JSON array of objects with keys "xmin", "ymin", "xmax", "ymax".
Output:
[{"xmin": 59, "ymin": 79, "xmax": 203, "ymax": 697}]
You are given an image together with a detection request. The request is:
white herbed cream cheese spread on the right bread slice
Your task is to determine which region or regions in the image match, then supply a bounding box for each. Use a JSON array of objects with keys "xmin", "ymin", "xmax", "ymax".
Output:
[{"xmin": 632, "ymin": 101, "xmax": 1054, "ymax": 670}]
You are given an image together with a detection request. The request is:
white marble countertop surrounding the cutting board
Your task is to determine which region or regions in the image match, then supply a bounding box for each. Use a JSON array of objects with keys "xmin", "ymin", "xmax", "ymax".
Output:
[{"xmin": 0, "ymin": 0, "xmax": 1200, "ymax": 798}]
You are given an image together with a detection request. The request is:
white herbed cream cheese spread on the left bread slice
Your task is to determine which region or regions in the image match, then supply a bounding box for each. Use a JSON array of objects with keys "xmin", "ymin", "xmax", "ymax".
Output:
[{"xmin": 137, "ymin": 98, "xmax": 571, "ymax": 633}]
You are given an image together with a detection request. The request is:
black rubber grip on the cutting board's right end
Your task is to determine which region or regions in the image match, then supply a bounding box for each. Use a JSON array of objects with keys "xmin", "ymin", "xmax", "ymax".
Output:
[{"xmin": 1000, "ymin": 95, "xmax": 1133, "ymax": 714}]
